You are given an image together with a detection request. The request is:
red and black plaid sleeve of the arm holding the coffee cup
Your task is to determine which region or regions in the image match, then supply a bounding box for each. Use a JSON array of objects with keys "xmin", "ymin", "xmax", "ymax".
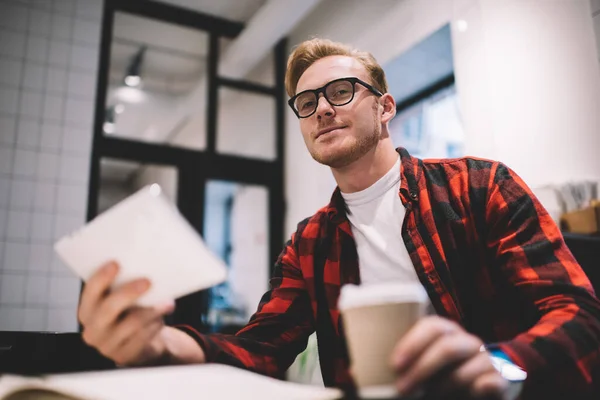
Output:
[{"xmin": 486, "ymin": 164, "xmax": 600, "ymax": 398}]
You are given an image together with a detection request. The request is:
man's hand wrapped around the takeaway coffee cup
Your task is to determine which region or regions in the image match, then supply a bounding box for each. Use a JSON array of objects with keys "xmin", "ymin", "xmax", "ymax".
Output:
[{"xmin": 391, "ymin": 317, "xmax": 508, "ymax": 399}]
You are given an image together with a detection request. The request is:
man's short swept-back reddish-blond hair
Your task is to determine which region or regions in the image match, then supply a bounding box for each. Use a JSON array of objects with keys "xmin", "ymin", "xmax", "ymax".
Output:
[{"xmin": 285, "ymin": 38, "xmax": 388, "ymax": 97}]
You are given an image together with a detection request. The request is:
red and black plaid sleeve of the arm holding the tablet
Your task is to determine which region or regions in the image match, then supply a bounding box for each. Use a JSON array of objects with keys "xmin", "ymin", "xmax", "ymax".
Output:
[{"xmin": 176, "ymin": 227, "xmax": 315, "ymax": 378}]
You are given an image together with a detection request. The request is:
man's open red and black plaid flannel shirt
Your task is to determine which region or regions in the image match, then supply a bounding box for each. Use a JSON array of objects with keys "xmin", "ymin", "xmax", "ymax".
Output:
[{"xmin": 180, "ymin": 149, "xmax": 600, "ymax": 398}]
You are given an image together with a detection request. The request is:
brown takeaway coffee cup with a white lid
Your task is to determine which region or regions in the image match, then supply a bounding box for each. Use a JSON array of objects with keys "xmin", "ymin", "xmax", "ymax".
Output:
[{"xmin": 338, "ymin": 283, "xmax": 429, "ymax": 398}]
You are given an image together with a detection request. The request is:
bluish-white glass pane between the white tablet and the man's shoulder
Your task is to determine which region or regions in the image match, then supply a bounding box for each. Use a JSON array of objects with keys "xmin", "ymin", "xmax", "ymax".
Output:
[{"xmin": 204, "ymin": 180, "xmax": 269, "ymax": 330}]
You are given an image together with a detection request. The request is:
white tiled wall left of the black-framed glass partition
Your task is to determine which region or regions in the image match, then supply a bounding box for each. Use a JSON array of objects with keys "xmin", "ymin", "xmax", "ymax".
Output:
[{"xmin": 0, "ymin": 0, "xmax": 102, "ymax": 331}]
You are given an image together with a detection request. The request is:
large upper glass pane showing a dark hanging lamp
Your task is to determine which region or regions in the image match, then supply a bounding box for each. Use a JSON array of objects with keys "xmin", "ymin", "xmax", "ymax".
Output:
[{"xmin": 103, "ymin": 11, "xmax": 209, "ymax": 150}]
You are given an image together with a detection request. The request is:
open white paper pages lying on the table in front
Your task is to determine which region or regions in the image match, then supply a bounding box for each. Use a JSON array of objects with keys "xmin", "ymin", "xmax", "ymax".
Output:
[{"xmin": 0, "ymin": 364, "xmax": 342, "ymax": 400}]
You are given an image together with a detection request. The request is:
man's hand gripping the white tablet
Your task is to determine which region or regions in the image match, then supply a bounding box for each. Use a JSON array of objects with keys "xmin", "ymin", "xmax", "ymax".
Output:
[{"xmin": 78, "ymin": 263, "xmax": 204, "ymax": 365}]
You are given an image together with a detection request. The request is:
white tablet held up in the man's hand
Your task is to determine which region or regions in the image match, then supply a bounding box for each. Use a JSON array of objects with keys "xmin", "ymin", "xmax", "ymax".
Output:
[{"xmin": 54, "ymin": 184, "xmax": 227, "ymax": 306}]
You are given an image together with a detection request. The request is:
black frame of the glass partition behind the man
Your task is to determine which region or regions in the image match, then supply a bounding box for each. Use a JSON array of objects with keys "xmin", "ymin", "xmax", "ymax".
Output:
[{"xmin": 87, "ymin": 0, "xmax": 287, "ymax": 331}]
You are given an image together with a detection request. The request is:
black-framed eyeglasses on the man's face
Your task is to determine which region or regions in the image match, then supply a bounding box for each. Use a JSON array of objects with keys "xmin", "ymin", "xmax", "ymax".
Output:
[{"xmin": 288, "ymin": 78, "xmax": 383, "ymax": 118}]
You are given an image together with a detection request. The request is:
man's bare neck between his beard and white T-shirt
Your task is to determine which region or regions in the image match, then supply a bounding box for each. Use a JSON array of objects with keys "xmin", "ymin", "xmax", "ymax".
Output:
[{"xmin": 331, "ymin": 137, "xmax": 398, "ymax": 193}]
